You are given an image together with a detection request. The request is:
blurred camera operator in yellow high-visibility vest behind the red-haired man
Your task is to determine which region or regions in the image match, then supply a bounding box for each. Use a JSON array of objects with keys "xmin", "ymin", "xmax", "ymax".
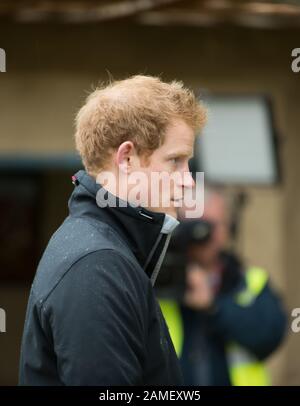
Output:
[{"xmin": 158, "ymin": 190, "xmax": 286, "ymax": 385}]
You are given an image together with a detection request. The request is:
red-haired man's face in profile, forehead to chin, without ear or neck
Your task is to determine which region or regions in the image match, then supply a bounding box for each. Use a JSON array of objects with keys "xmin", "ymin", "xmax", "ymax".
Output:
[{"xmin": 134, "ymin": 119, "xmax": 195, "ymax": 218}]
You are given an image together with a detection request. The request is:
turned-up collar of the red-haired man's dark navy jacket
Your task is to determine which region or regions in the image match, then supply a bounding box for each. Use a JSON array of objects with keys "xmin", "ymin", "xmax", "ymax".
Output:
[{"xmin": 69, "ymin": 170, "xmax": 179, "ymax": 284}]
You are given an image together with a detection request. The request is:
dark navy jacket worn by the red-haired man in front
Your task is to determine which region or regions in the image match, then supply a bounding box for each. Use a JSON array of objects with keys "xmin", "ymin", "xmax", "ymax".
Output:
[{"xmin": 19, "ymin": 171, "xmax": 182, "ymax": 385}]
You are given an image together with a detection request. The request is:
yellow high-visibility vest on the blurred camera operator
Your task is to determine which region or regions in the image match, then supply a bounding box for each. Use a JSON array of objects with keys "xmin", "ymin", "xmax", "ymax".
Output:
[{"xmin": 159, "ymin": 267, "xmax": 271, "ymax": 386}]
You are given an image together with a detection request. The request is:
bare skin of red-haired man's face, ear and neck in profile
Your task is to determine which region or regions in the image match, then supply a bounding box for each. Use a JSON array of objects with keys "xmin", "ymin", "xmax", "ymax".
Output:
[{"xmin": 96, "ymin": 119, "xmax": 195, "ymax": 218}]
